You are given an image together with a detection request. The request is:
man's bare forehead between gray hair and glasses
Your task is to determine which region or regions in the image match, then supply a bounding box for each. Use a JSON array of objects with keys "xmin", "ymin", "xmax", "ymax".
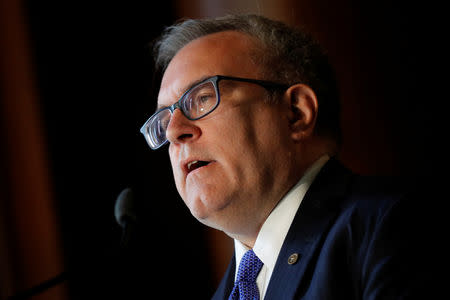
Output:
[{"xmin": 158, "ymin": 31, "xmax": 261, "ymax": 106}]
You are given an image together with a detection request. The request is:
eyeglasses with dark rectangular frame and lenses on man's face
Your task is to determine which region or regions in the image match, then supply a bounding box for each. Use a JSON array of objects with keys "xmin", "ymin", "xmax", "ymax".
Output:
[{"xmin": 141, "ymin": 75, "xmax": 288, "ymax": 150}]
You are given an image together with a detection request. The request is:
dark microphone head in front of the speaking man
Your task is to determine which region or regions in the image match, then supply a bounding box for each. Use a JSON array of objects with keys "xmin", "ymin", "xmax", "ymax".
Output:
[{"xmin": 114, "ymin": 188, "xmax": 137, "ymax": 247}]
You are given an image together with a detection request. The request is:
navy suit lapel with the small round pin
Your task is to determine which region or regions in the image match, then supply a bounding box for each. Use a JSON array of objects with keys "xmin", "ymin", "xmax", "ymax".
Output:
[{"xmin": 265, "ymin": 159, "xmax": 351, "ymax": 299}]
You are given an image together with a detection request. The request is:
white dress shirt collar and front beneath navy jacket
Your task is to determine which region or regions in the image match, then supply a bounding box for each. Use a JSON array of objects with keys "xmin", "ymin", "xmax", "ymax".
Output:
[{"xmin": 234, "ymin": 155, "xmax": 330, "ymax": 299}]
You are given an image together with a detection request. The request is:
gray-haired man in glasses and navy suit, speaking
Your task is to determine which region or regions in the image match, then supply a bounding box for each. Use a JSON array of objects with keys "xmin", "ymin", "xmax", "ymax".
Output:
[{"xmin": 141, "ymin": 15, "xmax": 425, "ymax": 299}]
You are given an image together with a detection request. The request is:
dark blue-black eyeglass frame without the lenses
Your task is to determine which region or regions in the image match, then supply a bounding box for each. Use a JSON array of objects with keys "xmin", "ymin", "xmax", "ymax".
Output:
[{"xmin": 140, "ymin": 75, "xmax": 289, "ymax": 150}]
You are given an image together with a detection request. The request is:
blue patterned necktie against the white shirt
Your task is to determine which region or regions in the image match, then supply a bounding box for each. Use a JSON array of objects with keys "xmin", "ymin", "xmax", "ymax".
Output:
[{"xmin": 228, "ymin": 250, "xmax": 263, "ymax": 300}]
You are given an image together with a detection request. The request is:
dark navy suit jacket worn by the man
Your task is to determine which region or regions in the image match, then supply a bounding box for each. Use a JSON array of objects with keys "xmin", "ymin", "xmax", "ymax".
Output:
[{"xmin": 212, "ymin": 159, "xmax": 432, "ymax": 300}]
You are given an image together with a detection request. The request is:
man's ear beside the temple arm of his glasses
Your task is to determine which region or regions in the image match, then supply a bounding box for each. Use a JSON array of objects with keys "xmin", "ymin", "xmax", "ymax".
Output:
[{"xmin": 285, "ymin": 84, "xmax": 319, "ymax": 142}]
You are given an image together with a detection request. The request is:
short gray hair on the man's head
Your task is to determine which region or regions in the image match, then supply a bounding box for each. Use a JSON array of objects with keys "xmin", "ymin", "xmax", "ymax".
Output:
[{"xmin": 153, "ymin": 15, "xmax": 341, "ymax": 144}]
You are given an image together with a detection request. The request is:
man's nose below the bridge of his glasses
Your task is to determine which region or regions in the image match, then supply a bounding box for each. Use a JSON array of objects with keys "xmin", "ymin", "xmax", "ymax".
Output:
[{"xmin": 166, "ymin": 109, "xmax": 201, "ymax": 144}]
